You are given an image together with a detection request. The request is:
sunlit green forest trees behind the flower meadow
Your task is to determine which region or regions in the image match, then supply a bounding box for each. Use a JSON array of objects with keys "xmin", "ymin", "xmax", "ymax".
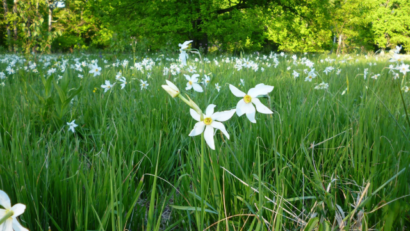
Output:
[{"xmin": 0, "ymin": 0, "xmax": 410, "ymax": 53}]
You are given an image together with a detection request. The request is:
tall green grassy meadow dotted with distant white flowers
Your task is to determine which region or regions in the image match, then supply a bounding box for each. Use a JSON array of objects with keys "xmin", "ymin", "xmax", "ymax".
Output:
[{"xmin": 0, "ymin": 53, "xmax": 410, "ymax": 231}]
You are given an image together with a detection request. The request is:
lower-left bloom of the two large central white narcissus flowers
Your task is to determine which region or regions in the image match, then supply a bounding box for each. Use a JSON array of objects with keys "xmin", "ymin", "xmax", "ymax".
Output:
[{"xmin": 189, "ymin": 104, "xmax": 235, "ymax": 150}]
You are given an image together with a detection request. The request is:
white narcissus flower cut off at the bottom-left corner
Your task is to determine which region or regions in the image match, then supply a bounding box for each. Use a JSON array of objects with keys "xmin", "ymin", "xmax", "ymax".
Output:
[{"xmin": 0, "ymin": 190, "xmax": 28, "ymax": 231}]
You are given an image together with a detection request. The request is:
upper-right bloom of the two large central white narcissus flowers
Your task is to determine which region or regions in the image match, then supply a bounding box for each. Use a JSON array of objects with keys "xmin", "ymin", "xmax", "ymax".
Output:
[{"xmin": 229, "ymin": 83, "xmax": 274, "ymax": 123}]
